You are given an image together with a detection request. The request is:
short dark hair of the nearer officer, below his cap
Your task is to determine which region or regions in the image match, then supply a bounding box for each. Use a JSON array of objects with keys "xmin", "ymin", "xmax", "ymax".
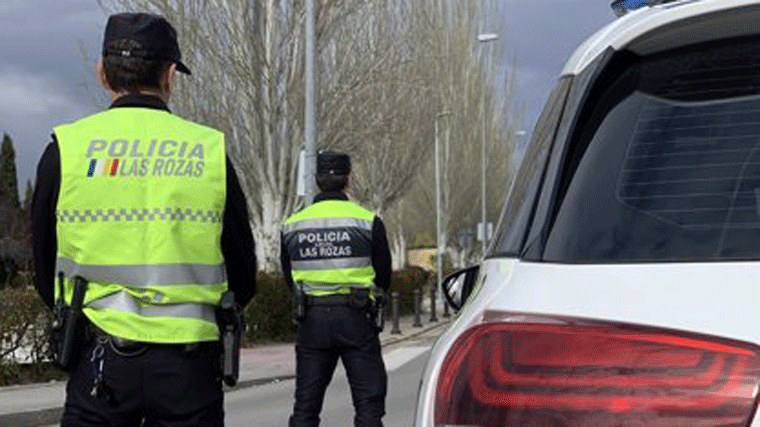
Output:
[{"xmin": 103, "ymin": 39, "xmax": 171, "ymax": 92}]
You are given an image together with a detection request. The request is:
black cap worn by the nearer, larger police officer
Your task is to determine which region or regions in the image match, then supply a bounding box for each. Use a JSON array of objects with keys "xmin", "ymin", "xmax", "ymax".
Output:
[{"xmin": 103, "ymin": 13, "xmax": 190, "ymax": 74}]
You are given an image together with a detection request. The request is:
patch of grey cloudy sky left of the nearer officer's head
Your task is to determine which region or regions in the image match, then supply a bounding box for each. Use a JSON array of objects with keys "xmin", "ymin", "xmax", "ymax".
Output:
[{"xmin": 0, "ymin": 0, "xmax": 106, "ymax": 191}]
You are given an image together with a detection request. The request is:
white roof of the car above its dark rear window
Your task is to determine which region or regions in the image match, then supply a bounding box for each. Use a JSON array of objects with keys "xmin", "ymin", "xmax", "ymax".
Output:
[{"xmin": 562, "ymin": 0, "xmax": 760, "ymax": 76}]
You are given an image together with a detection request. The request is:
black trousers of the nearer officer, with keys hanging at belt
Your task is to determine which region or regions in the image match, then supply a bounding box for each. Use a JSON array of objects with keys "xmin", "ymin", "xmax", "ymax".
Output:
[{"xmin": 61, "ymin": 337, "xmax": 224, "ymax": 427}]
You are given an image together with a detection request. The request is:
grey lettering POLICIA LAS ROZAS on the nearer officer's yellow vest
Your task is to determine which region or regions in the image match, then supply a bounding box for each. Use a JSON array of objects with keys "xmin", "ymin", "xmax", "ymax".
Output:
[{"xmin": 87, "ymin": 139, "xmax": 205, "ymax": 178}]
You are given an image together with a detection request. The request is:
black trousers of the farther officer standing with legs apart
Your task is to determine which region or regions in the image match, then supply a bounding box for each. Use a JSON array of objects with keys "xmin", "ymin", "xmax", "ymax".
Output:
[{"xmin": 290, "ymin": 305, "xmax": 388, "ymax": 427}]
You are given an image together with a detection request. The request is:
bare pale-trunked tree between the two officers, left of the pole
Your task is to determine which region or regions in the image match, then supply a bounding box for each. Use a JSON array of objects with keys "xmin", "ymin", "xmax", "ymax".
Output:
[{"xmin": 102, "ymin": 0, "xmax": 374, "ymax": 270}]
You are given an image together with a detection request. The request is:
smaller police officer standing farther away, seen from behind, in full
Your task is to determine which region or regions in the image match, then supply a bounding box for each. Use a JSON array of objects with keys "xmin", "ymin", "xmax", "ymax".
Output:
[{"xmin": 281, "ymin": 152, "xmax": 391, "ymax": 427}]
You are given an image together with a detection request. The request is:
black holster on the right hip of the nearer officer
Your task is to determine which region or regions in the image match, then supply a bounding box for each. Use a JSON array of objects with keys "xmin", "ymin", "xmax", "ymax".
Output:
[{"xmin": 216, "ymin": 290, "xmax": 243, "ymax": 387}]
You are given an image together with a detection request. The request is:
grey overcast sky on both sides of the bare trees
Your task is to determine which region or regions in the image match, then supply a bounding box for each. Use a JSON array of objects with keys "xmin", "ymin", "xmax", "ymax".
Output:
[{"xmin": 0, "ymin": 0, "xmax": 614, "ymax": 194}]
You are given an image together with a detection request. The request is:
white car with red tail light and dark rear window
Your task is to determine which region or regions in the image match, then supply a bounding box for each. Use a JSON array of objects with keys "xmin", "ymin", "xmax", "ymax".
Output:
[{"xmin": 415, "ymin": 0, "xmax": 760, "ymax": 427}]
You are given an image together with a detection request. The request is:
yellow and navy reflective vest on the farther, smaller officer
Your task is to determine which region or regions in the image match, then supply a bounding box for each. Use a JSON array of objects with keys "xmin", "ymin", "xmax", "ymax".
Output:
[{"xmin": 283, "ymin": 200, "xmax": 375, "ymax": 296}]
